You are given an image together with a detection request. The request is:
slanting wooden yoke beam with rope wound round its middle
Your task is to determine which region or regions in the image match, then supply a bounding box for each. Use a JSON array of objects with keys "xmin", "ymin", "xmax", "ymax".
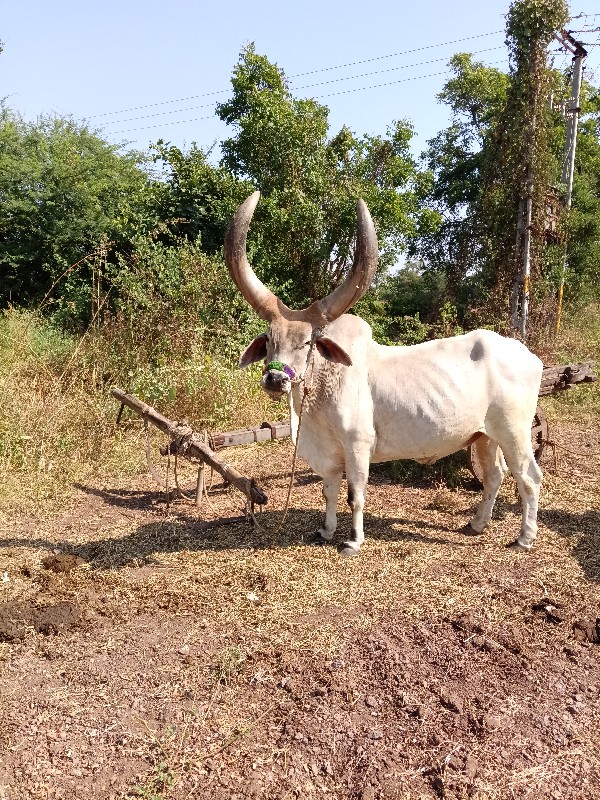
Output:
[{"xmin": 112, "ymin": 387, "xmax": 268, "ymax": 506}]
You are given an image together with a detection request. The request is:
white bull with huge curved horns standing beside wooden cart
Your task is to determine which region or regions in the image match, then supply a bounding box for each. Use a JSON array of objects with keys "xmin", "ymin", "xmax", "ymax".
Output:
[{"xmin": 225, "ymin": 192, "xmax": 542, "ymax": 555}]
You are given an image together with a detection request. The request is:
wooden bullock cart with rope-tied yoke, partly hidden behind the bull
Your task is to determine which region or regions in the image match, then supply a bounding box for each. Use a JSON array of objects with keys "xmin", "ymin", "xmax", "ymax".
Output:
[{"xmin": 112, "ymin": 361, "xmax": 596, "ymax": 510}]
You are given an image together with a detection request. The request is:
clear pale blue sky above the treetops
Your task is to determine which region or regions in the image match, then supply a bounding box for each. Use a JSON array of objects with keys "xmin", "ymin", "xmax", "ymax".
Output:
[{"xmin": 0, "ymin": 0, "xmax": 600, "ymax": 159}]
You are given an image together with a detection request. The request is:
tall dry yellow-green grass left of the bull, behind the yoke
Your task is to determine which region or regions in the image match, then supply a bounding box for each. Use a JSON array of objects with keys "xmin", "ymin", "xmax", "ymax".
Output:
[{"xmin": 0, "ymin": 309, "xmax": 276, "ymax": 513}]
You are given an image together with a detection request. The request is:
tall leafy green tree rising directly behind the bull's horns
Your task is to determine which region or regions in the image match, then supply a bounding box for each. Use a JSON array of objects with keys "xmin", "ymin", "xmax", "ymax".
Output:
[{"xmin": 217, "ymin": 45, "xmax": 436, "ymax": 305}]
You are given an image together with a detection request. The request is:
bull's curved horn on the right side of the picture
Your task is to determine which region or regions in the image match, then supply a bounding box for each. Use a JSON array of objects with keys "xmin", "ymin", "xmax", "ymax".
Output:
[{"xmin": 317, "ymin": 200, "xmax": 379, "ymax": 322}]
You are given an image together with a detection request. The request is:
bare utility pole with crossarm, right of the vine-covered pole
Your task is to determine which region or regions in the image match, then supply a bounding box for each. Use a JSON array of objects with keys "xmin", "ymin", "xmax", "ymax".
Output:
[{"xmin": 556, "ymin": 31, "xmax": 587, "ymax": 333}]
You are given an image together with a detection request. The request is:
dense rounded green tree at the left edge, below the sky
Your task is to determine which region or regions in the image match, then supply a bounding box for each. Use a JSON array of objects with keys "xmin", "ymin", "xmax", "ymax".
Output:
[{"xmin": 0, "ymin": 110, "xmax": 147, "ymax": 311}]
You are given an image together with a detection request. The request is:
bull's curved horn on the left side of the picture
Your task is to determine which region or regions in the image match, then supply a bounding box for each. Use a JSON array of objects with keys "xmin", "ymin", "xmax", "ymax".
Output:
[{"xmin": 225, "ymin": 192, "xmax": 286, "ymax": 322}]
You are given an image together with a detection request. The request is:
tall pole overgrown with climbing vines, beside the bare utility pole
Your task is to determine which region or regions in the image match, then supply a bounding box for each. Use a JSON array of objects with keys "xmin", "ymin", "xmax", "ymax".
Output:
[{"xmin": 486, "ymin": 0, "xmax": 568, "ymax": 336}]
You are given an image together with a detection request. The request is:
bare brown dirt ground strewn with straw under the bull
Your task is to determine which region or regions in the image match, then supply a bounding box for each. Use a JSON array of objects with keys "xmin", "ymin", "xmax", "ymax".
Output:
[{"xmin": 0, "ymin": 412, "xmax": 600, "ymax": 800}]
